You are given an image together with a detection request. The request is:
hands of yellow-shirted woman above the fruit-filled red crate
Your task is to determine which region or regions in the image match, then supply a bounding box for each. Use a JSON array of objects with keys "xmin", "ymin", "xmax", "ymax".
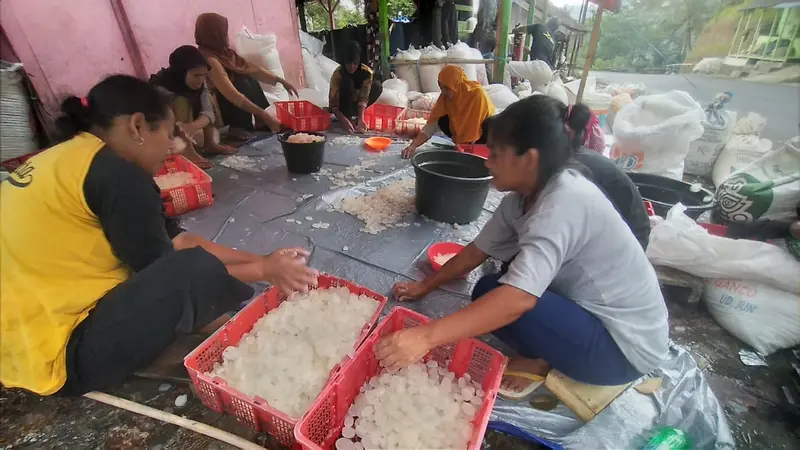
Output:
[{"xmin": 258, "ymin": 248, "xmax": 319, "ymax": 295}]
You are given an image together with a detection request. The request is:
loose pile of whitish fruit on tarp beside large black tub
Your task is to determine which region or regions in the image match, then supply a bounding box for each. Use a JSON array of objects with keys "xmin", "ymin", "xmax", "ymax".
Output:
[{"xmin": 336, "ymin": 178, "xmax": 415, "ymax": 234}]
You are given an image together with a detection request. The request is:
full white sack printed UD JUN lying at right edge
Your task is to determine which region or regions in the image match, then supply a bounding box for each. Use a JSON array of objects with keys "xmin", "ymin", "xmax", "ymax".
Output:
[{"xmin": 703, "ymin": 279, "xmax": 800, "ymax": 356}]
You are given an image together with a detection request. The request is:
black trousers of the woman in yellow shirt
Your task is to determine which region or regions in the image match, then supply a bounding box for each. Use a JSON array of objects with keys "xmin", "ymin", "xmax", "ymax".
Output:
[{"xmin": 58, "ymin": 247, "xmax": 253, "ymax": 396}]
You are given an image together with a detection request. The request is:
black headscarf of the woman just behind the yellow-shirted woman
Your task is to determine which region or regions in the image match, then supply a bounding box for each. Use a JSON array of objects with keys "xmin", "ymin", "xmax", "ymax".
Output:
[{"xmin": 150, "ymin": 45, "xmax": 208, "ymax": 119}]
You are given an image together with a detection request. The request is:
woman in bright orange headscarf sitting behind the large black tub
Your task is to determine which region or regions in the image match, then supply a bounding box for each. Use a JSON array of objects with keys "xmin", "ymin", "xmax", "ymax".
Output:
[{"xmin": 403, "ymin": 66, "xmax": 494, "ymax": 158}]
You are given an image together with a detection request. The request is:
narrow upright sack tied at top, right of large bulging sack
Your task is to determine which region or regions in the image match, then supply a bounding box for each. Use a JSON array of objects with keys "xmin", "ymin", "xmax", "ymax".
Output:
[{"xmin": 684, "ymin": 110, "xmax": 733, "ymax": 177}]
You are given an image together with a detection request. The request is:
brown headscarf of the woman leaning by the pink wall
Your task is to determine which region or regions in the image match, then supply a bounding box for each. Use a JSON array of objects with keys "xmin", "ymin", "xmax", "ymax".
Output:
[{"xmin": 194, "ymin": 13, "xmax": 259, "ymax": 75}]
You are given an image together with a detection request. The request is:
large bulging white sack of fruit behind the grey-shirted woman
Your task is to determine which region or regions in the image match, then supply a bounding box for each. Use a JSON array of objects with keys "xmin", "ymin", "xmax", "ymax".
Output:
[{"xmin": 611, "ymin": 91, "xmax": 706, "ymax": 180}]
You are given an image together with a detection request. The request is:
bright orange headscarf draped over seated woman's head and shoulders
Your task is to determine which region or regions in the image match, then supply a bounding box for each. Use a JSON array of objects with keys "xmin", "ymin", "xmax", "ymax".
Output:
[{"xmin": 428, "ymin": 65, "xmax": 494, "ymax": 144}]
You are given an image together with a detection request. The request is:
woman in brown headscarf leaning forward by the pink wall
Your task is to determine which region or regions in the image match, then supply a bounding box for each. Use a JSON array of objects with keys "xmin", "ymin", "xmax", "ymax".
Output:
[{"xmin": 194, "ymin": 13, "xmax": 297, "ymax": 131}]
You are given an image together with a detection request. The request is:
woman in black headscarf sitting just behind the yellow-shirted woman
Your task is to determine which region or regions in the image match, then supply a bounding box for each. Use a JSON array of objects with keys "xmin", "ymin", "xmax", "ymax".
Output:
[{"xmin": 150, "ymin": 45, "xmax": 236, "ymax": 169}]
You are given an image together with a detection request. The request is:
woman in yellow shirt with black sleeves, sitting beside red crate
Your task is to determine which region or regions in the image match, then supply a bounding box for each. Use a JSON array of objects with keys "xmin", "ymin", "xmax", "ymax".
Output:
[{"xmin": 0, "ymin": 75, "xmax": 316, "ymax": 395}]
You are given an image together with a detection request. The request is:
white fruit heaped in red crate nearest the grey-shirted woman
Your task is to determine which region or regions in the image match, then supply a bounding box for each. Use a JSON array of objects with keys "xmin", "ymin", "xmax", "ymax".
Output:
[{"xmin": 335, "ymin": 361, "xmax": 484, "ymax": 450}]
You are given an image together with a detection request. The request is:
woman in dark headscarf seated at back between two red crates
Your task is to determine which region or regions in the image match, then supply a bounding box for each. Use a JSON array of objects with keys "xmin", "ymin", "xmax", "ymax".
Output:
[{"xmin": 328, "ymin": 41, "xmax": 383, "ymax": 133}]
